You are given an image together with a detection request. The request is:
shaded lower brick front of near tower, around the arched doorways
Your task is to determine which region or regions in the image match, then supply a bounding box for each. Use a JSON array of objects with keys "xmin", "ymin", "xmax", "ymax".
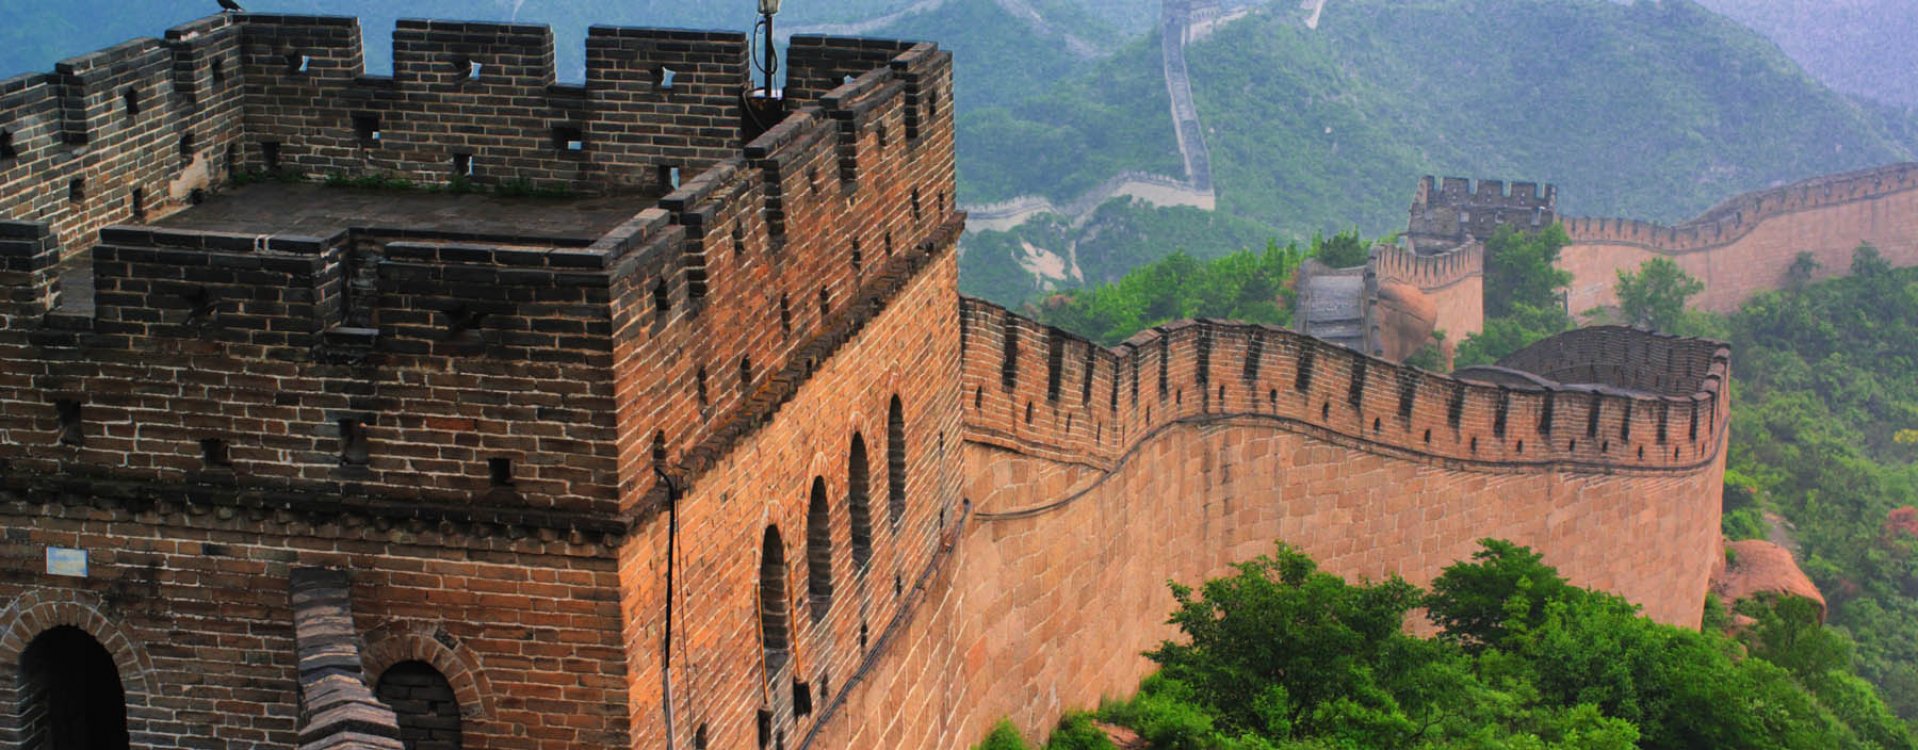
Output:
[{"xmin": 0, "ymin": 494, "xmax": 627, "ymax": 748}]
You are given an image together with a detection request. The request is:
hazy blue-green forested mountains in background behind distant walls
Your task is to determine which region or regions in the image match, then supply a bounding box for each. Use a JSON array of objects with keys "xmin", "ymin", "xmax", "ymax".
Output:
[{"xmin": 961, "ymin": 0, "xmax": 1914, "ymax": 301}]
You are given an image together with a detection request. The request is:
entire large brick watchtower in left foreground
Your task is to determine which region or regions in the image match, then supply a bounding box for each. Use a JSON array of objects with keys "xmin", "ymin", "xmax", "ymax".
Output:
[{"xmin": 0, "ymin": 15, "xmax": 961, "ymax": 748}]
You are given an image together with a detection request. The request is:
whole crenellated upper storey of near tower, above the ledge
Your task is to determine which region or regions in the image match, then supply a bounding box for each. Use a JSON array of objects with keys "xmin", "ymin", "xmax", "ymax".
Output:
[{"xmin": 0, "ymin": 13, "xmax": 955, "ymax": 526}]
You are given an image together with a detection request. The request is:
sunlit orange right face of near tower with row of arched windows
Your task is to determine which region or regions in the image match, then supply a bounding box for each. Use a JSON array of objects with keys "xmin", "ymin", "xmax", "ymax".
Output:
[{"xmin": 598, "ymin": 38, "xmax": 965, "ymax": 746}]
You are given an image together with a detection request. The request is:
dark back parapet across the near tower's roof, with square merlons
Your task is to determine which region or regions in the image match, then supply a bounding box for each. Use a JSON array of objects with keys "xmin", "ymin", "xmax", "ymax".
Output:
[{"xmin": 240, "ymin": 13, "xmax": 750, "ymax": 192}]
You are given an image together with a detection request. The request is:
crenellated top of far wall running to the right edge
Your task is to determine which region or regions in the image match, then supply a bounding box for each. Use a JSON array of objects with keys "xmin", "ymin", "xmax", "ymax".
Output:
[{"xmin": 1565, "ymin": 163, "xmax": 1918, "ymax": 255}]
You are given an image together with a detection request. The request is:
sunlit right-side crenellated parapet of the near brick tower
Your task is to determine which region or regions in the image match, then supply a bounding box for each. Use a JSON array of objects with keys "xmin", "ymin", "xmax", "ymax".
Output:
[{"xmin": 614, "ymin": 38, "xmax": 963, "ymax": 518}]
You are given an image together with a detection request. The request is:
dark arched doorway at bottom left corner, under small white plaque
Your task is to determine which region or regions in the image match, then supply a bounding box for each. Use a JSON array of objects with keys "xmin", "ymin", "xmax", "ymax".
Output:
[{"xmin": 19, "ymin": 625, "xmax": 130, "ymax": 750}]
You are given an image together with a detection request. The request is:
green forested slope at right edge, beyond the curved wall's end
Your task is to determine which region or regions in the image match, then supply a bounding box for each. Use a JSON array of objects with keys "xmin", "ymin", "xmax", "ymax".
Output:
[{"xmin": 1726, "ymin": 251, "xmax": 1918, "ymax": 721}]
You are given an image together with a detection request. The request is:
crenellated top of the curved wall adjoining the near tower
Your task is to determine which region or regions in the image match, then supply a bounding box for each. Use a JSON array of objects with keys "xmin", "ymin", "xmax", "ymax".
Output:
[{"xmin": 961, "ymin": 299, "xmax": 1730, "ymax": 479}]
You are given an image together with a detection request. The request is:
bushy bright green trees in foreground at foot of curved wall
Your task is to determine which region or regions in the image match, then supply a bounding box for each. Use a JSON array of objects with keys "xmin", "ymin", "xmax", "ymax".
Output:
[{"xmin": 1055, "ymin": 539, "xmax": 1910, "ymax": 750}]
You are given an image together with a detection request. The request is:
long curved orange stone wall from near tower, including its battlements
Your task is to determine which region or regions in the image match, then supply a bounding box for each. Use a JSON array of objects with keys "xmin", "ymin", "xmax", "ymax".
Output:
[{"xmin": 802, "ymin": 299, "xmax": 1726, "ymax": 748}]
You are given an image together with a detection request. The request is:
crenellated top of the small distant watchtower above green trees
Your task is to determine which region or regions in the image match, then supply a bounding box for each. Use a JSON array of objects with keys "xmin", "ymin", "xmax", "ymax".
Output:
[{"xmin": 1406, "ymin": 176, "xmax": 1557, "ymax": 255}]
